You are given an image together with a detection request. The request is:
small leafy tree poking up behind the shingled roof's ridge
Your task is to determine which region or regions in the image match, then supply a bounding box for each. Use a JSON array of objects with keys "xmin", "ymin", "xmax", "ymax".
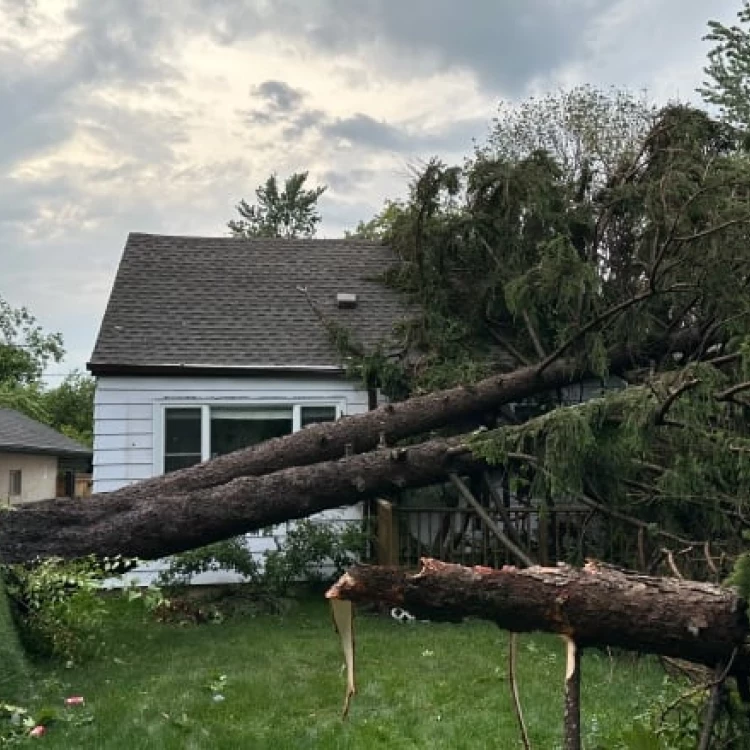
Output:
[{"xmin": 227, "ymin": 172, "xmax": 326, "ymax": 239}]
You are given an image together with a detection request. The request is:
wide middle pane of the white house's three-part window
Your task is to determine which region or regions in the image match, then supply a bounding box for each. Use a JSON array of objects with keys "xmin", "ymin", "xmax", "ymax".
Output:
[{"xmin": 211, "ymin": 406, "xmax": 292, "ymax": 456}]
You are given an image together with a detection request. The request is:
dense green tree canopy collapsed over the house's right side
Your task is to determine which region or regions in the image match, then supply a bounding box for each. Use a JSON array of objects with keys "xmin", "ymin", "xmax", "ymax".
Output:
[{"xmin": 338, "ymin": 87, "xmax": 750, "ymax": 562}]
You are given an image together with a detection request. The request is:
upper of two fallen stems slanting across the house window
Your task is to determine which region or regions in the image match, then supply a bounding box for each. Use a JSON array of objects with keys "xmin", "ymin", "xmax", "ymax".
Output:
[{"xmin": 91, "ymin": 329, "xmax": 707, "ymax": 506}]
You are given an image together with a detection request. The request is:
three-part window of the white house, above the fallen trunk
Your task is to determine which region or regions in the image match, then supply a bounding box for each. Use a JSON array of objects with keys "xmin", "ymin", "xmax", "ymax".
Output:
[{"xmin": 163, "ymin": 404, "xmax": 340, "ymax": 473}]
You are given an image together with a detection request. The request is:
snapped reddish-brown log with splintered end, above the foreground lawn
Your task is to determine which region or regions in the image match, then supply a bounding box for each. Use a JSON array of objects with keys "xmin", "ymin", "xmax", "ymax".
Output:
[{"xmin": 326, "ymin": 558, "xmax": 750, "ymax": 674}]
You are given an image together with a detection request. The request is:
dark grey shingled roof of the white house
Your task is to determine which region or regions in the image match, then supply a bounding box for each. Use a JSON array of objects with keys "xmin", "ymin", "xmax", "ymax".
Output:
[{"xmin": 89, "ymin": 234, "xmax": 414, "ymax": 374}]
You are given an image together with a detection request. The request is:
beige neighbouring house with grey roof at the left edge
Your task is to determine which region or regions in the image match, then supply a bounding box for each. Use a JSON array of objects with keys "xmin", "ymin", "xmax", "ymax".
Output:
[{"xmin": 0, "ymin": 408, "xmax": 91, "ymax": 504}]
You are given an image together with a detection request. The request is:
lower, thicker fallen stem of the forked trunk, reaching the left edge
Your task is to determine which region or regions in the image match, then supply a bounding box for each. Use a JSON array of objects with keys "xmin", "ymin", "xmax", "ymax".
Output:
[{"xmin": 0, "ymin": 438, "xmax": 485, "ymax": 563}]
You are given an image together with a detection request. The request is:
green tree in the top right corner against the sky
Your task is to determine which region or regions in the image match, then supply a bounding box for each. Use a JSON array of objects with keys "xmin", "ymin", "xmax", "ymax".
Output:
[{"xmin": 698, "ymin": 0, "xmax": 750, "ymax": 127}]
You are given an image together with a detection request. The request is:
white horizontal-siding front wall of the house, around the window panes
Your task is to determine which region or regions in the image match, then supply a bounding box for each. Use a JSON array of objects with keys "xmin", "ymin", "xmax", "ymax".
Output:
[{"xmin": 93, "ymin": 375, "xmax": 368, "ymax": 583}]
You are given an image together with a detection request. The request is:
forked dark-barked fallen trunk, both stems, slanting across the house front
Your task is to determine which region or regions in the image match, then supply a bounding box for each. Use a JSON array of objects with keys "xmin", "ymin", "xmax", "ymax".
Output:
[{"xmin": 0, "ymin": 330, "xmax": 716, "ymax": 563}]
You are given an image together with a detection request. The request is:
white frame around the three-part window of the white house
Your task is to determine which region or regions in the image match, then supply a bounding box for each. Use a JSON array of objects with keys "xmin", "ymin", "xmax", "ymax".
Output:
[{"xmin": 153, "ymin": 398, "xmax": 346, "ymax": 475}]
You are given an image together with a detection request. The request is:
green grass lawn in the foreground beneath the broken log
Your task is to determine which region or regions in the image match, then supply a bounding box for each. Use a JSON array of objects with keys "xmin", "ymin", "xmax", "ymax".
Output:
[{"xmin": 23, "ymin": 597, "xmax": 678, "ymax": 750}]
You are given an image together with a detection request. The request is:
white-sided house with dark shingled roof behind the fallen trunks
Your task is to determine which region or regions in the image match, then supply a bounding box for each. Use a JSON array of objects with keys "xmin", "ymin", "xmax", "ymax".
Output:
[{"xmin": 88, "ymin": 234, "xmax": 406, "ymax": 577}]
